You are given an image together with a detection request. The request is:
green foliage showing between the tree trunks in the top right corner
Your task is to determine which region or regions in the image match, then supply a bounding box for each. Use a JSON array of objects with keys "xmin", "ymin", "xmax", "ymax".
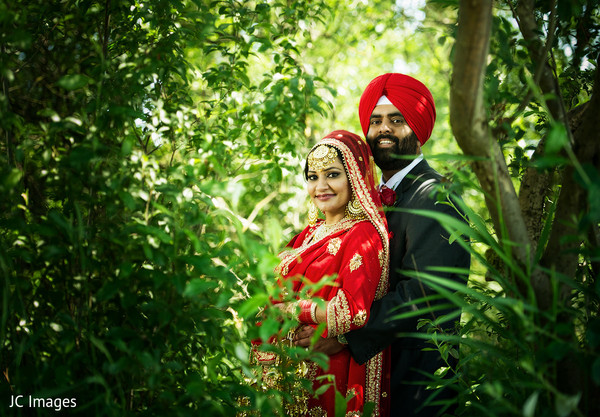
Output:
[{"xmin": 485, "ymin": 1, "xmax": 600, "ymax": 179}]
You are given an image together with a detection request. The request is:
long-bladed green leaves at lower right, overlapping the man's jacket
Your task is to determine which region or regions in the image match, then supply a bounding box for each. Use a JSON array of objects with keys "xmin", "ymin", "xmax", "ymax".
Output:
[{"xmin": 400, "ymin": 167, "xmax": 600, "ymax": 417}]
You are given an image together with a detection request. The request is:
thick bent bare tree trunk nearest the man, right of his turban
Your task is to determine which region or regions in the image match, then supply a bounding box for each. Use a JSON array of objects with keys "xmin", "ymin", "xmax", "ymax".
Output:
[{"xmin": 450, "ymin": 0, "xmax": 551, "ymax": 304}]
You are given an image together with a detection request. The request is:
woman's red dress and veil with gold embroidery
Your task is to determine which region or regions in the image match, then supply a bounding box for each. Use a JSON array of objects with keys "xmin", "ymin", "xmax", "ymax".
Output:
[{"xmin": 276, "ymin": 131, "xmax": 389, "ymax": 416}]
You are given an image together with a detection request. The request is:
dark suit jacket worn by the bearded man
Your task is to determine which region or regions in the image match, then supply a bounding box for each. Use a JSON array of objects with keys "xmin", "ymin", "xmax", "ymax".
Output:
[{"xmin": 346, "ymin": 160, "xmax": 470, "ymax": 417}]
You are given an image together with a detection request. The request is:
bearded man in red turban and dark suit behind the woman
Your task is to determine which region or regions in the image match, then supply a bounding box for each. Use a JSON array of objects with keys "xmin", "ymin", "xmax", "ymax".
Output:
[{"xmin": 296, "ymin": 73, "xmax": 470, "ymax": 417}]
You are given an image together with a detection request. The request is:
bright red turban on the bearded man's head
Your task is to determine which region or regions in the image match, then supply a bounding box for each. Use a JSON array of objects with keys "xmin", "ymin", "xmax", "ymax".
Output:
[{"xmin": 358, "ymin": 73, "xmax": 435, "ymax": 145}]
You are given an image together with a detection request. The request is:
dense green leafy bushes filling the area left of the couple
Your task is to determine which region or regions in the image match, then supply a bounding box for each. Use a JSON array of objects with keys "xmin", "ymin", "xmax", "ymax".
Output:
[{"xmin": 0, "ymin": 1, "xmax": 338, "ymax": 416}]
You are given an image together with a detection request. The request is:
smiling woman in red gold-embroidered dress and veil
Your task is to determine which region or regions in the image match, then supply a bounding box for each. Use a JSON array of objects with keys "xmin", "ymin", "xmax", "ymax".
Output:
[{"xmin": 253, "ymin": 130, "xmax": 389, "ymax": 416}]
